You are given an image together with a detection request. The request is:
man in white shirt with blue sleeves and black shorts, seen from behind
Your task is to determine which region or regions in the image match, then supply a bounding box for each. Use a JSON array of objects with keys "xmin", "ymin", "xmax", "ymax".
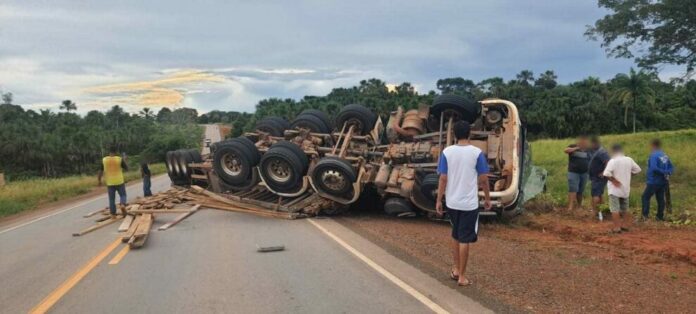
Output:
[{"xmin": 435, "ymin": 121, "xmax": 491, "ymax": 286}]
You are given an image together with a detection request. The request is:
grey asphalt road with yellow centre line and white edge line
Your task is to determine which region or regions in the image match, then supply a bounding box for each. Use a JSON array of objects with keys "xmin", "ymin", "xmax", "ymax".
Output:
[{"xmin": 0, "ymin": 176, "xmax": 486, "ymax": 313}]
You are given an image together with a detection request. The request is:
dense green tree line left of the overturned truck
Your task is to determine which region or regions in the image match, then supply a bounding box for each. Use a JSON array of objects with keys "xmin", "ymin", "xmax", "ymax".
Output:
[{"xmin": 0, "ymin": 93, "xmax": 203, "ymax": 179}]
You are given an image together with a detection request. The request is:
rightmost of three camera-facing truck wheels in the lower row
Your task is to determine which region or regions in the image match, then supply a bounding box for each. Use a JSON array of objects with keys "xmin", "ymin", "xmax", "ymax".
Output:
[{"xmin": 311, "ymin": 157, "xmax": 358, "ymax": 196}]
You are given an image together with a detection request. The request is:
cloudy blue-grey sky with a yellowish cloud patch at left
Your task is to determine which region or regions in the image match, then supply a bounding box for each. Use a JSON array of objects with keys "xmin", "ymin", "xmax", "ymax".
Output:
[{"xmin": 0, "ymin": 0, "xmax": 633, "ymax": 113}]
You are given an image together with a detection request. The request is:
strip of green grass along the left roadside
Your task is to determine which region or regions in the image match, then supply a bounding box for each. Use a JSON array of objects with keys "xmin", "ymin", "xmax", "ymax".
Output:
[{"xmin": 0, "ymin": 164, "xmax": 166, "ymax": 217}]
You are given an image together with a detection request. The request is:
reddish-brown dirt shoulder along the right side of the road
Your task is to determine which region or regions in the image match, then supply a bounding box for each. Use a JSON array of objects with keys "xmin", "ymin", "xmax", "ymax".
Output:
[{"xmin": 338, "ymin": 207, "xmax": 696, "ymax": 313}]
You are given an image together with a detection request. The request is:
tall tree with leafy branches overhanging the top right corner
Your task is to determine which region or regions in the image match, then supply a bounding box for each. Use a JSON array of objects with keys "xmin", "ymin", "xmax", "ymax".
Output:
[{"xmin": 585, "ymin": 0, "xmax": 696, "ymax": 78}]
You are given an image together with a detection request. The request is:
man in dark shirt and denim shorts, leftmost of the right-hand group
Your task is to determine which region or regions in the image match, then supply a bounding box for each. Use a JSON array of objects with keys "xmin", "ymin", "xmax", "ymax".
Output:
[{"xmin": 564, "ymin": 135, "xmax": 590, "ymax": 211}]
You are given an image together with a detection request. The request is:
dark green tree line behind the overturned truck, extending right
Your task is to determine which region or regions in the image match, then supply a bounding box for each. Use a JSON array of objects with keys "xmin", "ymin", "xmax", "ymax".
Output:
[{"xmin": 198, "ymin": 73, "xmax": 696, "ymax": 138}]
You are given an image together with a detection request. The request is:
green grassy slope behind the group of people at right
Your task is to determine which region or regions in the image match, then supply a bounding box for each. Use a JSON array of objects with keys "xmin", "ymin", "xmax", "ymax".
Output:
[{"xmin": 531, "ymin": 129, "xmax": 696, "ymax": 220}]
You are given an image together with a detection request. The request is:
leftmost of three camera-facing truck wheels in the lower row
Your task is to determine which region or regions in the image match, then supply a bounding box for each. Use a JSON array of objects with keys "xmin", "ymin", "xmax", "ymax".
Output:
[{"xmin": 213, "ymin": 141, "xmax": 258, "ymax": 186}]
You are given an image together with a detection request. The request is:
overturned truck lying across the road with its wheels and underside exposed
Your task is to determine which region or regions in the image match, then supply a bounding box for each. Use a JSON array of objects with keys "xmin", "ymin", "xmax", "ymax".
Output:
[{"xmin": 167, "ymin": 95, "xmax": 544, "ymax": 217}]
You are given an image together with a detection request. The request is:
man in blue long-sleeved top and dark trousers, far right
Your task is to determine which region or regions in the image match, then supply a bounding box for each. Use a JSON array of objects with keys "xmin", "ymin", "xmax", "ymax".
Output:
[{"xmin": 642, "ymin": 139, "xmax": 674, "ymax": 220}]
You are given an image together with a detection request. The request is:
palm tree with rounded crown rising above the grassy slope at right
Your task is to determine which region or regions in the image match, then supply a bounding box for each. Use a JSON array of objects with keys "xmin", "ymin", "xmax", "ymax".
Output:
[{"xmin": 613, "ymin": 68, "xmax": 655, "ymax": 133}]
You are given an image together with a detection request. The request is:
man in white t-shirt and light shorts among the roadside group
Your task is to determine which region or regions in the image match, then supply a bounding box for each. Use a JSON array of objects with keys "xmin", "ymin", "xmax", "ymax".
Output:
[{"xmin": 604, "ymin": 144, "xmax": 640, "ymax": 233}]
